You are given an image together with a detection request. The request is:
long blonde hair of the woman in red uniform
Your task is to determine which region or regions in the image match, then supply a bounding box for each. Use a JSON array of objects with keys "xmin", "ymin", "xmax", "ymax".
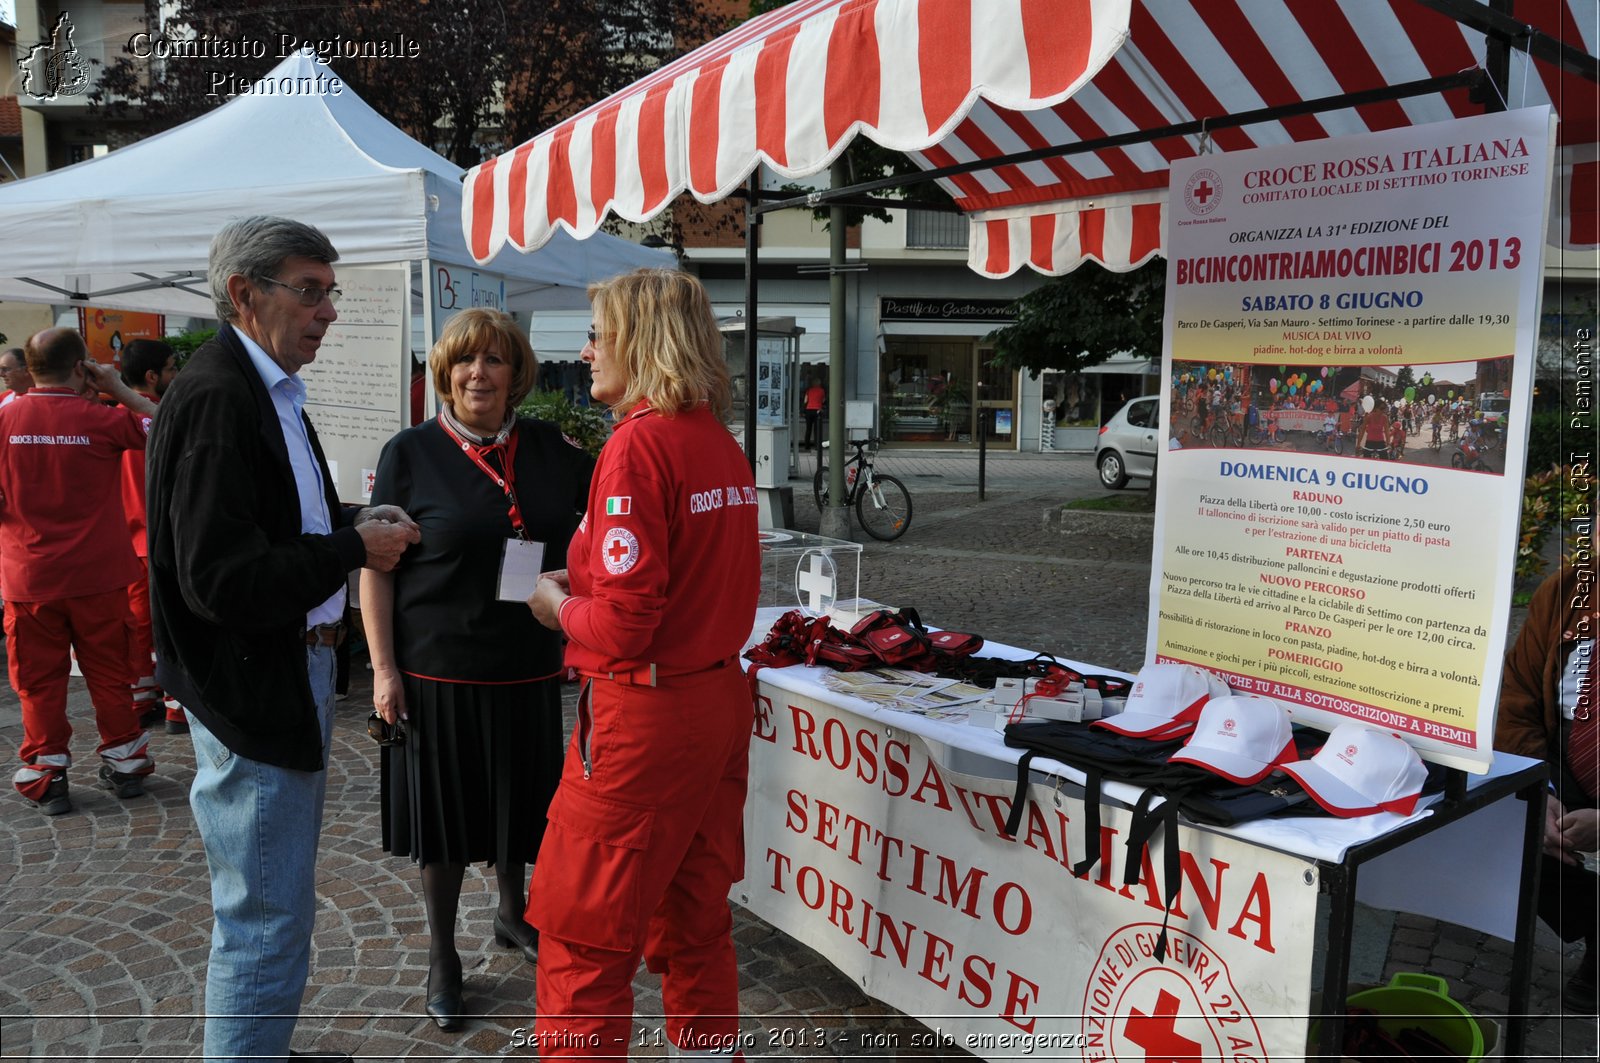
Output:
[{"xmin": 589, "ymin": 269, "xmax": 733, "ymax": 423}]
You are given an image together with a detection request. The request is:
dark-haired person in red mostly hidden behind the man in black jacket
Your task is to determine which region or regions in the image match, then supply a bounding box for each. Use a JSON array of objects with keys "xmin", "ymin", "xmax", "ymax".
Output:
[{"xmin": 122, "ymin": 339, "xmax": 189, "ymax": 735}]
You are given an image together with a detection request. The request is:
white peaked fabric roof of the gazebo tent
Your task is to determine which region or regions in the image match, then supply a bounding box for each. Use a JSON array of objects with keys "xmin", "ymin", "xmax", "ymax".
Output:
[{"xmin": 0, "ymin": 53, "xmax": 672, "ymax": 317}]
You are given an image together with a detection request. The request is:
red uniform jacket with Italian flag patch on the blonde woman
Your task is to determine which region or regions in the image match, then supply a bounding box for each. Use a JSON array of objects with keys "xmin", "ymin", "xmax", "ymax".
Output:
[{"xmin": 562, "ymin": 405, "xmax": 762, "ymax": 674}]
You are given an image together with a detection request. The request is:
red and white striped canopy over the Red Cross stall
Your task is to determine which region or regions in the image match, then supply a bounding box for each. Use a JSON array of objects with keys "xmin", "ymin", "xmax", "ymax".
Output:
[{"xmin": 462, "ymin": 0, "xmax": 1600, "ymax": 277}]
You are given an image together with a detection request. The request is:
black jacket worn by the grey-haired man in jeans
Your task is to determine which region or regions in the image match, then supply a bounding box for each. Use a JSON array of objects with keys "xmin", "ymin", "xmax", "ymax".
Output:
[{"xmin": 146, "ymin": 325, "xmax": 366, "ymax": 772}]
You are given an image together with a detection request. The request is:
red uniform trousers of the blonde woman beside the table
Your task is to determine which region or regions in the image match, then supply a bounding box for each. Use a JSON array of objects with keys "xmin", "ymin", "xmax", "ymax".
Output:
[{"xmin": 528, "ymin": 661, "xmax": 754, "ymax": 1060}]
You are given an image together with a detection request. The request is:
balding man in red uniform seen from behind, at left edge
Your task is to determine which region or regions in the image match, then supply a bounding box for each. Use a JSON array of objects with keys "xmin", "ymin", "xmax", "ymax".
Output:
[{"xmin": 0, "ymin": 328, "xmax": 155, "ymax": 815}]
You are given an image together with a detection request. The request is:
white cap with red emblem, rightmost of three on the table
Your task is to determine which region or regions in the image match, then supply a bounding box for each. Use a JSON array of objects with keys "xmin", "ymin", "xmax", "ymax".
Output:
[{"xmin": 1283, "ymin": 724, "xmax": 1427, "ymax": 816}]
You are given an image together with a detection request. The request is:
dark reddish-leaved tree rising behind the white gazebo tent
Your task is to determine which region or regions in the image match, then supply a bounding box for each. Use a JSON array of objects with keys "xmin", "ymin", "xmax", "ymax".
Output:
[{"xmin": 93, "ymin": 0, "xmax": 723, "ymax": 166}]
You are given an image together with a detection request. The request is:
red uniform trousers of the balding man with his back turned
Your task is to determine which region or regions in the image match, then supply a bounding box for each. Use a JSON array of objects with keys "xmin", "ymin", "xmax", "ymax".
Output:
[{"xmin": 5, "ymin": 588, "xmax": 154, "ymax": 800}]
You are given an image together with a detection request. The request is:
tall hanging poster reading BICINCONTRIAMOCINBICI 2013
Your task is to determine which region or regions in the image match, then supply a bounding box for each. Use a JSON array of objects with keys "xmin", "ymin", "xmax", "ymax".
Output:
[{"xmin": 1147, "ymin": 107, "xmax": 1552, "ymax": 772}]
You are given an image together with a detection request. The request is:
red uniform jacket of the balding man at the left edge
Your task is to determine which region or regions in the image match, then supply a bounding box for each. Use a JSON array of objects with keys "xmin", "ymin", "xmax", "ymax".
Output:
[{"xmin": 0, "ymin": 387, "xmax": 150, "ymax": 602}]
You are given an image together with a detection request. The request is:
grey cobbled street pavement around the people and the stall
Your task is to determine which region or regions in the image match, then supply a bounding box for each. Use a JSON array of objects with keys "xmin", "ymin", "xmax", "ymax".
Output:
[{"xmin": 0, "ymin": 451, "xmax": 1595, "ymax": 1060}]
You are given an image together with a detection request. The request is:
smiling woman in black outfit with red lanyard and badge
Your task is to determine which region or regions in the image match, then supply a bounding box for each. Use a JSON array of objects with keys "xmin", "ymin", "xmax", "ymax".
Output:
[{"xmin": 362, "ymin": 309, "xmax": 594, "ymax": 1029}]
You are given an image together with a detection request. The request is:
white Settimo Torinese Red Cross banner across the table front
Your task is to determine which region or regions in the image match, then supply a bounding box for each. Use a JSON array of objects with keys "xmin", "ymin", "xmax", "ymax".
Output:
[{"xmin": 733, "ymin": 687, "xmax": 1317, "ymax": 1061}]
